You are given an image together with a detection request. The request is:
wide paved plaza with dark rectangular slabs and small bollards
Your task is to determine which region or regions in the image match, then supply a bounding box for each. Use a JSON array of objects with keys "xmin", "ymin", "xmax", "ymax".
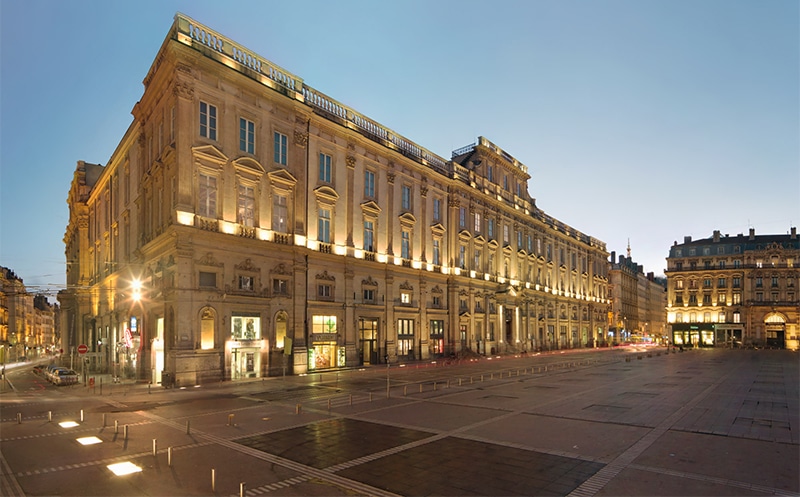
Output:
[{"xmin": 0, "ymin": 348, "xmax": 800, "ymax": 497}]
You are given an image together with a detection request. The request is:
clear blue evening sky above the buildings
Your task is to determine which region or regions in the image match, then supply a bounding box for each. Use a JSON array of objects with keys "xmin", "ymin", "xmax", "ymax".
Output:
[{"xmin": 0, "ymin": 0, "xmax": 800, "ymax": 298}]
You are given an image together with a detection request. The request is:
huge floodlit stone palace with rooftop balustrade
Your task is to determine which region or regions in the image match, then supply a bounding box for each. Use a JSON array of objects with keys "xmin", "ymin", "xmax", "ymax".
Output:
[{"xmin": 59, "ymin": 11, "xmax": 608, "ymax": 385}]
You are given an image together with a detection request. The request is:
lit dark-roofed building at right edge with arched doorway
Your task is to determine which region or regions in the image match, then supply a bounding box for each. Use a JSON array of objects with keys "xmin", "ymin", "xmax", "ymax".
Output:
[{"xmin": 667, "ymin": 227, "xmax": 800, "ymax": 350}]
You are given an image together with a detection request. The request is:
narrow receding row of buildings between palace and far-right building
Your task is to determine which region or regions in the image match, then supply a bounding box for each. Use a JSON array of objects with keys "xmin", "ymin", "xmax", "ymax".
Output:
[{"xmin": 606, "ymin": 247, "xmax": 669, "ymax": 344}]
